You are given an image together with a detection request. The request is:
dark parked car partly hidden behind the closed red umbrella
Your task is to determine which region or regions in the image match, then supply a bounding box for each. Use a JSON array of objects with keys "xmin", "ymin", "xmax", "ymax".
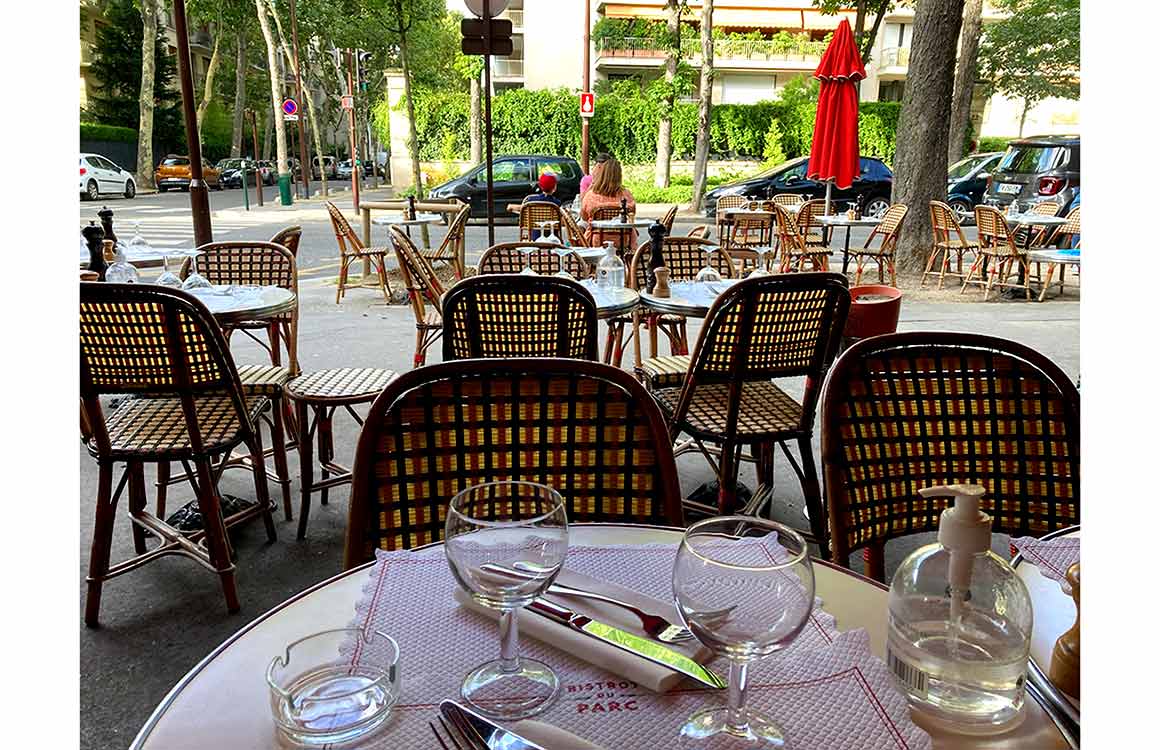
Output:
[{"xmin": 704, "ymin": 156, "xmax": 894, "ymax": 217}]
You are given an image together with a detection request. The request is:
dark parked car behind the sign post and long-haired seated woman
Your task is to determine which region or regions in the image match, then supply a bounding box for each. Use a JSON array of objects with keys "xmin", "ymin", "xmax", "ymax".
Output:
[{"xmin": 430, "ymin": 154, "xmax": 583, "ymax": 217}]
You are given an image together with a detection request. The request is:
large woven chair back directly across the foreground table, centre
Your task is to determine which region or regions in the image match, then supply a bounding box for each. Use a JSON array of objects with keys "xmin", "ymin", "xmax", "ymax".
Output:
[{"xmin": 343, "ymin": 358, "xmax": 684, "ymax": 569}]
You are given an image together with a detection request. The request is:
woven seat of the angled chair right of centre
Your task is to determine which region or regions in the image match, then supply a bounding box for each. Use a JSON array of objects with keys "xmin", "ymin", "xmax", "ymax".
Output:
[{"xmin": 654, "ymin": 380, "xmax": 807, "ymax": 440}]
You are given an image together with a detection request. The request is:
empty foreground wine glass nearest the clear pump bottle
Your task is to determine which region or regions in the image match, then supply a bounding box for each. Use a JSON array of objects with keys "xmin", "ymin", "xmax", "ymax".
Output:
[{"xmin": 673, "ymin": 516, "xmax": 814, "ymax": 748}]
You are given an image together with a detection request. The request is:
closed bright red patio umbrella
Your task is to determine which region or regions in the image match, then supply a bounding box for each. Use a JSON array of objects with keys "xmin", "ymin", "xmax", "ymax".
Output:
[{"xmin": 806, "ymin": 19, "xmax": 867, "ymax": 213}]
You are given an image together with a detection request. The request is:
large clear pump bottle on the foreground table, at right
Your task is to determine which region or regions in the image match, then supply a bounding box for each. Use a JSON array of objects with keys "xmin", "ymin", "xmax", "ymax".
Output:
[{"xmin": 886, "ymin": 485, "xmax": 1031, "ymax": 735}]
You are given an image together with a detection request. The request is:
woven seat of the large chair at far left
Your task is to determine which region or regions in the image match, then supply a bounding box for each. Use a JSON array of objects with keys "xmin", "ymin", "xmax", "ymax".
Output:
[{"xmin": 88, "ymin": 394, "xmax": 269, "ymax": 460}]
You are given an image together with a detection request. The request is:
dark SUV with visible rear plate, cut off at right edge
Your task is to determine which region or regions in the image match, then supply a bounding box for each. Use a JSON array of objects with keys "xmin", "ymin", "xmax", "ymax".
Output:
[{"xmin": 984, "ymin": 136, "xmax": 1080, "ymax": 212}]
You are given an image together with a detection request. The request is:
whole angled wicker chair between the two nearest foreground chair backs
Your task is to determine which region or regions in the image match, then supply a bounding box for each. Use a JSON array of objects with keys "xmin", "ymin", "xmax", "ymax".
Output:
[{"xmin": 653, "ymin": 274, "xmax": 850, "ymax": 545}]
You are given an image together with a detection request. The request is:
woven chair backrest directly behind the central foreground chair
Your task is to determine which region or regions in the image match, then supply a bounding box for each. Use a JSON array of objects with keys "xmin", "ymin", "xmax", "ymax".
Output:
[{"xmin": 443, "ymin": 274, "xmax": 600, "ymax": 362}]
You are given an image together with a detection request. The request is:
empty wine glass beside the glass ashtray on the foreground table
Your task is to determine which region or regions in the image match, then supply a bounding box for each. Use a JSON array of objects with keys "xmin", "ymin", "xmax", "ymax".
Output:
[{"xmin": 444, "ymin": 481, "xmax": 568, "ymax": 720}]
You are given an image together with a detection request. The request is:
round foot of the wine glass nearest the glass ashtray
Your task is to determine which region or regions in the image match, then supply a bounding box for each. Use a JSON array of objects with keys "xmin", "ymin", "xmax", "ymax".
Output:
[{"xmin": 459, "ymin": 658, "xmax": 560, "ymax": 720}]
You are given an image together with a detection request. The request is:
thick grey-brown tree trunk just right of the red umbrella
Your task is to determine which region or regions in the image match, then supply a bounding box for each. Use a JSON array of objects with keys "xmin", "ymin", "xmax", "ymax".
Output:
[{"xmin": 893, "ymin": 0, "xmax": 964, "ymax": 271}]
